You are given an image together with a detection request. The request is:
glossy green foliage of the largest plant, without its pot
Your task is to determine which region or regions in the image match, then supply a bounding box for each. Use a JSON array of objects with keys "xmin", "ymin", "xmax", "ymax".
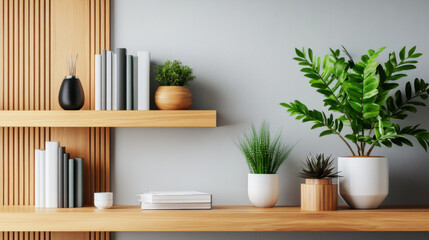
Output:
[{"xmin": 280, "ymin": 47, "xmax": 429, "ymax": 156}]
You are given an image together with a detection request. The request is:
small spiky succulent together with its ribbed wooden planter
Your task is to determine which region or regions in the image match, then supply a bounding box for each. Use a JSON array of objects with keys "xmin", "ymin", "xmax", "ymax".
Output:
[{"xmin": 299, "ymin": 154, "xmax": 339, "ymax": 211}]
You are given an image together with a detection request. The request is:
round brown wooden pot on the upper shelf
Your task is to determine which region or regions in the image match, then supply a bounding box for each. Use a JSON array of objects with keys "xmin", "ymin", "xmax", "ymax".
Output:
[{"xmin": 155, "ymin": 86, "xmax": 192, "ymax": 110}]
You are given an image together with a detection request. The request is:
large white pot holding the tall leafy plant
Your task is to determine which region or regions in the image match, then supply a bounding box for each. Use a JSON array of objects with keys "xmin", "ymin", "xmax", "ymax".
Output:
[{"xmin": 338, "ymin": 157, "xmax": 389, "ymax": 209}]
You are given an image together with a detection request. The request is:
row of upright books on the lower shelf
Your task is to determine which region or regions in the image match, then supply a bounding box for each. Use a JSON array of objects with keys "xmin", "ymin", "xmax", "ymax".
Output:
[{"xmin": 35, "ymin": 142, "xmax": 84, "ymax": 208}]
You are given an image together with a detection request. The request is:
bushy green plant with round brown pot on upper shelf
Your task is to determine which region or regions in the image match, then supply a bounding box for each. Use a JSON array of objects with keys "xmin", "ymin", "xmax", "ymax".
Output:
[{"xmin": 155, "ymin": 60, "xmax": 195, "ymax": 110}]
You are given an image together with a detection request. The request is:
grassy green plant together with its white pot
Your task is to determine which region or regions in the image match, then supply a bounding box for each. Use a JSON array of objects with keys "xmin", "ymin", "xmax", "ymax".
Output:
[{"xmin": 237, "ymin": 122, "xmax": 292, "ymax": 207}]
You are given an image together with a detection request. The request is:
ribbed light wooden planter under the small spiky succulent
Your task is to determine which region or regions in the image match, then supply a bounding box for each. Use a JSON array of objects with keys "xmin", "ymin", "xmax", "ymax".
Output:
[{"xmin": 301, "ymin": 179, "xmax": 338, "ymax": 211}]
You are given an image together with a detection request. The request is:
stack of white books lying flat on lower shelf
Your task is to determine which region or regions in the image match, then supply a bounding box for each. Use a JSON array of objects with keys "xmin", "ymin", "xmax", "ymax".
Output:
[{"xmin": 137, "ymin": 191, "xmax": 212, "ymax": 209}]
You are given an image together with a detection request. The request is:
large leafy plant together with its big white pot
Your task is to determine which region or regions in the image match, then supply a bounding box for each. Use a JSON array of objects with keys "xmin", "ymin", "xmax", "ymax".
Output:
[{"xmin": 281, "ymin": 47, "xmax": 429, "ymax": 208}]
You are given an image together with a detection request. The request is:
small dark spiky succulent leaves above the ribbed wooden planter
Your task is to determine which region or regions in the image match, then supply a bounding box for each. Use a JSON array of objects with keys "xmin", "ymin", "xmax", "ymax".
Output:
[{"xmin": 299, "ymin": 153, "xmax": 339, "ymax": 179}]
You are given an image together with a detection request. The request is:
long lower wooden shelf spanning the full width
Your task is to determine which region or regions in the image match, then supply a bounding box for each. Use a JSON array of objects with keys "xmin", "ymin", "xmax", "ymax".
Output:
[{"xmin": 0, "ymin": 206, "xmax": 429, "ymax": 231}]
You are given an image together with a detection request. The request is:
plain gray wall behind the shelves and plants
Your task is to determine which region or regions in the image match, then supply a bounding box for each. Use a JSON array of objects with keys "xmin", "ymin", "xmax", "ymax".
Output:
[{"xmin": 112, "ymin": 0, "xmax": 429, "ymax": 239}]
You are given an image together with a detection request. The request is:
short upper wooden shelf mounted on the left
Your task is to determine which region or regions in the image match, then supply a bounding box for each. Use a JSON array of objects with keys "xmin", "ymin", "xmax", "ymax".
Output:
[{"xmin": 0, "ymin": 110, "xmax": 216, "ymax": 127}]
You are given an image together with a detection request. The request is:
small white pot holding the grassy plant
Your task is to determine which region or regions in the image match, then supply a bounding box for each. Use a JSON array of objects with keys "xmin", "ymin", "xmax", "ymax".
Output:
[{"xmin": 248, "ymin": 173, "xmax": 279, "ymax": 207}]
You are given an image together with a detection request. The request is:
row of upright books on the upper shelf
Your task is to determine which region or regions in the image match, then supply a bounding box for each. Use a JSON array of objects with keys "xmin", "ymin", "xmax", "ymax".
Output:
[{"xmin": 95, "ymin": 48, "xmax": 150, "ymax": 110}]
